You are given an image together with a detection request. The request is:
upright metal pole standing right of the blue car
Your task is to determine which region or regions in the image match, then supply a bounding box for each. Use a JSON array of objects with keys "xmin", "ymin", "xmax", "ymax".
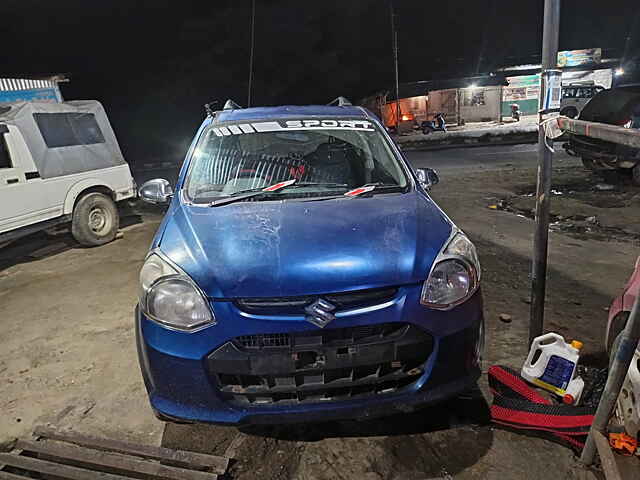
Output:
[{"xmin": 529, "ymin": 0, "xmax": 560, "ymax": 345}]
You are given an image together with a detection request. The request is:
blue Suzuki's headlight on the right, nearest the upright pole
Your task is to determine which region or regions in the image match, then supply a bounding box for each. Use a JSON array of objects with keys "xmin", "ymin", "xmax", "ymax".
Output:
[{"xmin": 420, "ymin": 232, "xmax": 480, "ymax": 310}]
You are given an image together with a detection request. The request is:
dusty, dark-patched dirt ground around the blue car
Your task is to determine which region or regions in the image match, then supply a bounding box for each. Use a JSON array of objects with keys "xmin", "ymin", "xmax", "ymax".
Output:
[{"xmin": 0, "ymin": 145, "xmax": 640, "ymax": 479}]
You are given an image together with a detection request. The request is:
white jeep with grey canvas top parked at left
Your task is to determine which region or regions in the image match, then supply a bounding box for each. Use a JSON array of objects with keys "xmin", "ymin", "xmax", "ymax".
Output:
[{"xmin": 0, "ymin": 100, "xmax": 136, "ymax": 246}]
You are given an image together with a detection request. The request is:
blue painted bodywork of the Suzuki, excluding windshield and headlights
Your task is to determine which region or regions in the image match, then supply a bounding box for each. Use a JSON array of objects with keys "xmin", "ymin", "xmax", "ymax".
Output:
[{"xmin": 136, "ymin": 107, "xmax": 484, "ymax": 424}]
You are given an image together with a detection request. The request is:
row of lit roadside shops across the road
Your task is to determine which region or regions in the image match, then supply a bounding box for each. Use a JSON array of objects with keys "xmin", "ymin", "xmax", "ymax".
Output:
[{"xmin": 360, "ymin": 48, "xmax": 618, "ymax": 131}]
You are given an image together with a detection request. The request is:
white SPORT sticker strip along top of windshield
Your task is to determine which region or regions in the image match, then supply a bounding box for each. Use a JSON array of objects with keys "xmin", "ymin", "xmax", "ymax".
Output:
[{"xmin": 212, "ymin": 119, "xmax": 374, "ymax": 137}]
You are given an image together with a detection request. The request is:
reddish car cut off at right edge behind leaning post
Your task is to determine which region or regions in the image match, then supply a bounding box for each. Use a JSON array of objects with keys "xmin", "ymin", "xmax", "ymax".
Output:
[{"xmin": 605, "ymin": 257, "xmax": 640, "ymax": 438}]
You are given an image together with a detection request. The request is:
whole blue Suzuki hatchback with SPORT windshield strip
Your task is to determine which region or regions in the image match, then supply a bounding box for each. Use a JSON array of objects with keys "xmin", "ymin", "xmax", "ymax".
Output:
[{"xmin": 135, "ymin": 103, "xmax": 484, "ymax": 424}]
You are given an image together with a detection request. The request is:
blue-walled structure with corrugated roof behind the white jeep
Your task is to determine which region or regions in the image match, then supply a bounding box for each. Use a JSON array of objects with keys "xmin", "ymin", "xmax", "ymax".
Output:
[{"xmin": 0, "ymin": 75, "xmax": 69, "ymax": 103}]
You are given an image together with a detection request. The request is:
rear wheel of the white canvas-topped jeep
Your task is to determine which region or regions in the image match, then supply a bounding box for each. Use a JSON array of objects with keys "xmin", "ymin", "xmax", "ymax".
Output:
[{"xmin": 71, "ymin": 192, "xmax": 120, "ymax": 247}]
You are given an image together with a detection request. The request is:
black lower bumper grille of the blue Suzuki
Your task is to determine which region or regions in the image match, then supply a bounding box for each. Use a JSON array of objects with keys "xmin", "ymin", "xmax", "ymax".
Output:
[{"xmin": 207, "ymin": 323, "xmax": 433, "ymax": 405}]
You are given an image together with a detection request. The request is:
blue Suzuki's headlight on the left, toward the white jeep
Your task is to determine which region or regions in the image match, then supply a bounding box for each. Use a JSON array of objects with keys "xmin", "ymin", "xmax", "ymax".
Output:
[{"xmin": 140, "ymin": 253, "xmax": 215, "ymax": 332}]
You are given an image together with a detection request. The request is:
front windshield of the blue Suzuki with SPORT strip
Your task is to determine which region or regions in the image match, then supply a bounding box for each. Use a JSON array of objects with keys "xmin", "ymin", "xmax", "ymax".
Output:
[{"xmin": 186, "ymin": 119, "xmax": 407, "ymax": 203}]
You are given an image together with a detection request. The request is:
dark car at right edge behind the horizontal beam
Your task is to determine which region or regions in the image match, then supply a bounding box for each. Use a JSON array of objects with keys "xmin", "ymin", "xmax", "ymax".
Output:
[{"xmin": 563, "ymin": 85, "xmax": 640, "ymax": 185}]
